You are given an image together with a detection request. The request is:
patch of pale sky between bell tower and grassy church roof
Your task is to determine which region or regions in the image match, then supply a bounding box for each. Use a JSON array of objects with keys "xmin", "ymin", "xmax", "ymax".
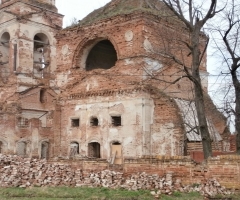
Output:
[{"xmin": 56, "ymin": 0, "xmax": 111, "ymax": 27}]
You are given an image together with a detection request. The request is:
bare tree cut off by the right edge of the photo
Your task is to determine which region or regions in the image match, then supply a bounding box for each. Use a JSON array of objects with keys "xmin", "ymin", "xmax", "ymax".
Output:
[{"xmin": 214, "ymin": 0, "xmax": 240, "ymax": 154}]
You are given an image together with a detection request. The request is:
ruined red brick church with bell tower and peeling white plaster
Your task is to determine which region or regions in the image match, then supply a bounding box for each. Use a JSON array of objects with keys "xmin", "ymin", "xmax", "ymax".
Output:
[{"xmin": 0, "ymin": 0, "xmax": 232, "ymax": 164}]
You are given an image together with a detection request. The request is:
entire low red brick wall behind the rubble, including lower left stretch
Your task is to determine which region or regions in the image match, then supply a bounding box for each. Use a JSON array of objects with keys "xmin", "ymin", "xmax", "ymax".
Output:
[{"xmin": 52, "ymin": 155, "xmax": 240, "ymax": 189}]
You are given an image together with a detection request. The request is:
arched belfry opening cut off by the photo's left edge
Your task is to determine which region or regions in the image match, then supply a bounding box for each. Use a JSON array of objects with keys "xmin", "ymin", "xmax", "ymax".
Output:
[{"xmin": 0, "ymin": 32, "xmax": 10, "ymax": 67}]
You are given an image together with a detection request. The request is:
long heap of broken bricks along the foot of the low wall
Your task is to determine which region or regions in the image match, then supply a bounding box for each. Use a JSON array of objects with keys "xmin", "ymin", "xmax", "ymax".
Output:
[{"xmin": 0, "ymin": 154, "xmax": 233, "ymax": 197}]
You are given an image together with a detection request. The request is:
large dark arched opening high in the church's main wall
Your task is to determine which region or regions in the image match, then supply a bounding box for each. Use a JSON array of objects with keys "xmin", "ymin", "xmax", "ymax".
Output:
[{"xmin": 86, "ymin": 40, "xmax": 117, "ymax": 71}]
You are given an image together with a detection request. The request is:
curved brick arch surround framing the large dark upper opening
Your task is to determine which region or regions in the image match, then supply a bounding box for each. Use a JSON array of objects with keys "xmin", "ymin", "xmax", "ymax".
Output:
[{"xmin": 73, "ymin": 36, "xmax": 119, "ymax": 69}]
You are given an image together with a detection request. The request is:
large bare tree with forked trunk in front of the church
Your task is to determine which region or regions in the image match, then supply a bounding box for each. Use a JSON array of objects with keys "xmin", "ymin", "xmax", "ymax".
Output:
[{"xmin": 158, "ymin": 0, "xmax": 222, "ymax": 159}]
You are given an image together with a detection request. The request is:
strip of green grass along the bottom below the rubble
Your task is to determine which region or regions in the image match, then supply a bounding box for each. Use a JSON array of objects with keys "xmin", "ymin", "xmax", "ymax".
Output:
[{"xmin": 0, "ymin": 187, "xmax": 239, "ymax": 200}]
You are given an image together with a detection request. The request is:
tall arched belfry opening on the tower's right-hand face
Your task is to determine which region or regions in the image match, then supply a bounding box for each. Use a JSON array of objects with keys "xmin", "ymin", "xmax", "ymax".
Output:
[{"xmin": 33, "ymin": 33, "xmax": 50, "ymax": 78}]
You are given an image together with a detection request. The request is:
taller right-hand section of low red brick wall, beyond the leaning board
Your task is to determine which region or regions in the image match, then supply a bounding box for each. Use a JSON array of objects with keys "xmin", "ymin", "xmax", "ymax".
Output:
[{"xmin": 124, "ymin": 155, "xmax": 240, "ymax": 189}]
